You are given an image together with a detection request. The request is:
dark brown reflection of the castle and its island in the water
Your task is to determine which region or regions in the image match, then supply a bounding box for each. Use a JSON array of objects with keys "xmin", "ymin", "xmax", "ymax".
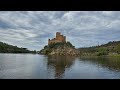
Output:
[{"xmin": 48, "ymin": 55, "xmax": 75, "ymax": 78}]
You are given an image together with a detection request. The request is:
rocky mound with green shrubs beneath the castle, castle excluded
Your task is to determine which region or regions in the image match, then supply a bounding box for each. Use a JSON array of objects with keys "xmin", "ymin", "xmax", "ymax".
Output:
[{"xmin": 40, "ymin": 42, "xmax": 79, "ymax": 56}]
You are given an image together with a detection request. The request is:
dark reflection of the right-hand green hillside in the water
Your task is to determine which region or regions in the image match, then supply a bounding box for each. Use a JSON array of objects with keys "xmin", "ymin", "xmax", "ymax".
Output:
[{"xmin": 80, "ymin": 57, "xmax": 120, "ymax": 71}]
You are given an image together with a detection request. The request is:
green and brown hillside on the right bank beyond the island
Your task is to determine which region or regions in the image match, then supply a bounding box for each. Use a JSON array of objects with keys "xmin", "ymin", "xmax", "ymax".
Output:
[{"xmin": 78, "ymin": 41, "xmax": 120, "ymax": 56}]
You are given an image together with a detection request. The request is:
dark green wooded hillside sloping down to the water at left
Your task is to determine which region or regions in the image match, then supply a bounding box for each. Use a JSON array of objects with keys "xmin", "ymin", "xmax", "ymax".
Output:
[{"xmin": 0, "ymin": 42, "xmax": 36, "ymax": 53}]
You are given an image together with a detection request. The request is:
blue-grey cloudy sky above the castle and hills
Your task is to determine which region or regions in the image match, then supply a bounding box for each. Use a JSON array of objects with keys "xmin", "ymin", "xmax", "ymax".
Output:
[{"xmin": 0, "ymin": 11, "xmax": 120, "ymax": 50}]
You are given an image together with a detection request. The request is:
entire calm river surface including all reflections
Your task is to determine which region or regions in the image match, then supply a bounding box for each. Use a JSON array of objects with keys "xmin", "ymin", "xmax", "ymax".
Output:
[{"xmin": 0, "ymin": 54, "xmax": 120, "ymax": 79}]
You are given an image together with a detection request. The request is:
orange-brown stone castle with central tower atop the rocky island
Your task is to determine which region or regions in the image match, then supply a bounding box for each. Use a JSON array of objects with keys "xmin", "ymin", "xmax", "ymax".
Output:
[{"xmin": 48, "ymin": 32, "xmax": 66, "ymax": 45}]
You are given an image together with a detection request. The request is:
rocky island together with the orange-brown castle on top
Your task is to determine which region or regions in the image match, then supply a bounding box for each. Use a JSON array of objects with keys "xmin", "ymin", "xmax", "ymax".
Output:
[{"xmin": 40, "ymin": 32, "xmax": 79, "ymax": 55}]
